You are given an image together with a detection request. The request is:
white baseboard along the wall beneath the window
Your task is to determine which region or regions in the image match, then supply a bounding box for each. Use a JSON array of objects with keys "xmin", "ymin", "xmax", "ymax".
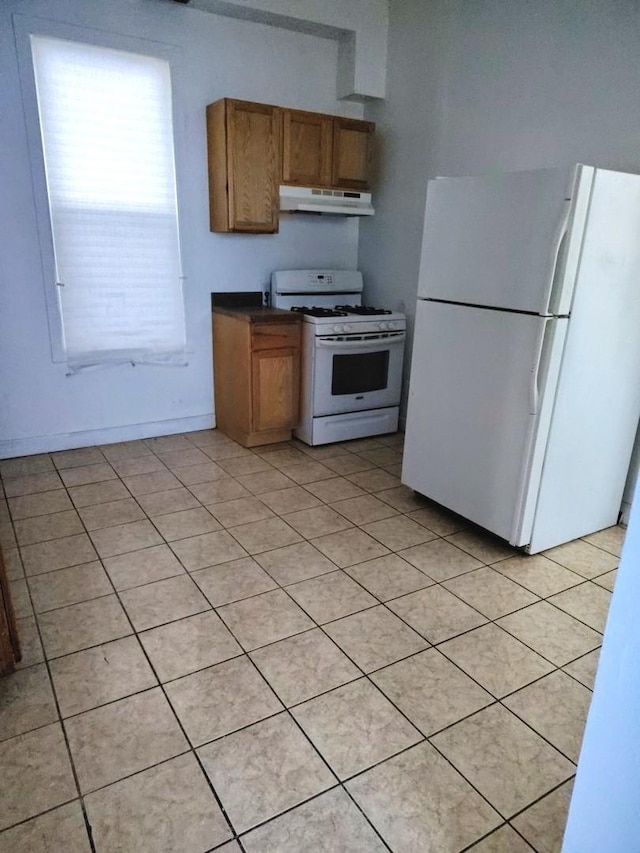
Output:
[{"xmin": 0, "ymin": 412, "xmax": 216, "ymax": 459}]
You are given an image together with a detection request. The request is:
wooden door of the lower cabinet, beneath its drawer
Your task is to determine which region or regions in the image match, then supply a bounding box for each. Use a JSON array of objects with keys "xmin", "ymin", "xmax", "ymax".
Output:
[{"xmin": 251, "ymin": 349, "xmax": 300, "ymax": 432}]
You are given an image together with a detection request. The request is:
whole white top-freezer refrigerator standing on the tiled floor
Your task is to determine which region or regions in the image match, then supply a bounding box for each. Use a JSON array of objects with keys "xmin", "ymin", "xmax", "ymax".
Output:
[{"xmin": 402, "ymin": 166, "xmax": 640, "ymax": 553}]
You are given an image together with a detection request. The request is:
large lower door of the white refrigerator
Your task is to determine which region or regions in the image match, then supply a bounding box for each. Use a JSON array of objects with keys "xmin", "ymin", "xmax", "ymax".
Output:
[{"xmin": 402, "ymin": 301, "xmax": 568, "ymax": 545}]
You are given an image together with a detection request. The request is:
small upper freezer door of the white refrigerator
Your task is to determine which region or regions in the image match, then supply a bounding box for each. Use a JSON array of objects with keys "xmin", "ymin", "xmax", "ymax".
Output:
[{"xmin": 418, "ymin": 168, "xmax": 575, "ymax": 314}]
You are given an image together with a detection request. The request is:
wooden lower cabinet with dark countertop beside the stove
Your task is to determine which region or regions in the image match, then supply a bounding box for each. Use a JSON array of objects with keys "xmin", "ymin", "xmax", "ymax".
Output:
[{"xmin": 213, "ymin": 310, "xmax": 300, "ymax": 447}]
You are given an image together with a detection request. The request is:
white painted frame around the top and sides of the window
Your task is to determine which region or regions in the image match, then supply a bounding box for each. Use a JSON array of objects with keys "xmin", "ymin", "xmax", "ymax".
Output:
[{"xmin": 13, "ymin": 13, "xmax": 193, "ymax": 364}]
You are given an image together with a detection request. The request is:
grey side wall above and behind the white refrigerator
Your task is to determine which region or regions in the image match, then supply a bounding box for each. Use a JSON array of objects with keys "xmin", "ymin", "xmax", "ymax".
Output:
[{"xmin": 359, "ymin": 0, "xmax": 640, "ymax": 414}]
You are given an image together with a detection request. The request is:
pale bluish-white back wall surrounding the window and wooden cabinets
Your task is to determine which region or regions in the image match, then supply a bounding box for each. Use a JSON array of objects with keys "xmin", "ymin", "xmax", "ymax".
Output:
[{"xmin": 0, "ymin": 0, "xmax": 362, "ymax": 457}]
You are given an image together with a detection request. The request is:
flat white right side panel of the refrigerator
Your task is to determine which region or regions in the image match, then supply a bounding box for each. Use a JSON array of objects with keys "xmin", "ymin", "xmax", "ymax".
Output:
[{"xmin": 529, "ymin": 169, "xmax": 640, "ymax": 553}]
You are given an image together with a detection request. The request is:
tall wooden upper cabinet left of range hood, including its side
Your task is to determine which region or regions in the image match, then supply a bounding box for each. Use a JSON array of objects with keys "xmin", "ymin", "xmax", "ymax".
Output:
[{"xmin": 207, "ymin": 98, "xmax": 281, "ymax": 233}]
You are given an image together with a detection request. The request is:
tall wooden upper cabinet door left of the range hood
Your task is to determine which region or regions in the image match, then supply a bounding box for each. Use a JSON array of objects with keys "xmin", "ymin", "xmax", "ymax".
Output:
[{"xmin": 227, "ymin": 100, "xmax": 280, "ymax": 233}]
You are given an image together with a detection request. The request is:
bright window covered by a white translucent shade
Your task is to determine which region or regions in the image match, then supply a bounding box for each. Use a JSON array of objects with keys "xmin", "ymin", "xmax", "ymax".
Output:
[{"xmin": 31, "ymin": 36, "xmax": 185, "ymax": 370}]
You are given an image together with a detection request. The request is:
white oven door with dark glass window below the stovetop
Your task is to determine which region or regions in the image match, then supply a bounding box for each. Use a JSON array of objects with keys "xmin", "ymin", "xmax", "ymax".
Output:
[{"xmin": 313, "ymin": 332, "xmax": 406, "ymax": 417}]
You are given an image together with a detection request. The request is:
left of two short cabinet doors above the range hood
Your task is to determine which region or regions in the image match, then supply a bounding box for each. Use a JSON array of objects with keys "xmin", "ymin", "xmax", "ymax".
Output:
[{"xmin": 282, "ymin": 110, "xmax": 333, "ymax": 187}]
